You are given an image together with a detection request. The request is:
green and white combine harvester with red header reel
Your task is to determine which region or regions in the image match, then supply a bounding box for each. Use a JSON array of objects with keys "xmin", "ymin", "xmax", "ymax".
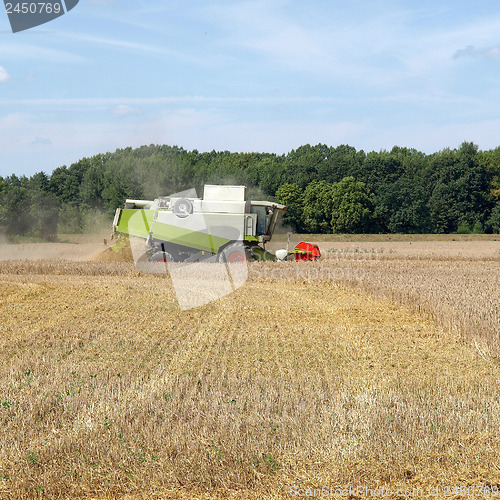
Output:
[{"xmin": 113, "ymin": 185, "xmax": 321, "ymax": 263}]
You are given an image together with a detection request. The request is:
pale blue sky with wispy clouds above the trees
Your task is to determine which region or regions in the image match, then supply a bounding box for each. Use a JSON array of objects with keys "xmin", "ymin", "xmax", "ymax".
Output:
[{"xmin": 0, "ymin": 0, "xmax": 500, "ymax": 176}]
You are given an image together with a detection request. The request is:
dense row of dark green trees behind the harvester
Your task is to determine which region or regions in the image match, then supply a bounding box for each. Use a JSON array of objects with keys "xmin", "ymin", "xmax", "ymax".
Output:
[{"xmin": 0, "ymin": 142, "xmax": 500, "ymax": 239}]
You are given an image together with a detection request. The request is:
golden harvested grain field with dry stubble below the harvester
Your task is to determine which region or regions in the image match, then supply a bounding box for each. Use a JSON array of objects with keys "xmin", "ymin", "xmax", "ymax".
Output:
[{"xmin": 0, "ymin": 235, "xmax": 500, "ymax": 498}]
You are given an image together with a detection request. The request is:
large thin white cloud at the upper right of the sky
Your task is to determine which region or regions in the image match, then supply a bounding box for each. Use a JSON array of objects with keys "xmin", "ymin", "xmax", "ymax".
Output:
[{"xmin": 203, "ymin": 0, "xmax": 500, "ymax": 95}]
